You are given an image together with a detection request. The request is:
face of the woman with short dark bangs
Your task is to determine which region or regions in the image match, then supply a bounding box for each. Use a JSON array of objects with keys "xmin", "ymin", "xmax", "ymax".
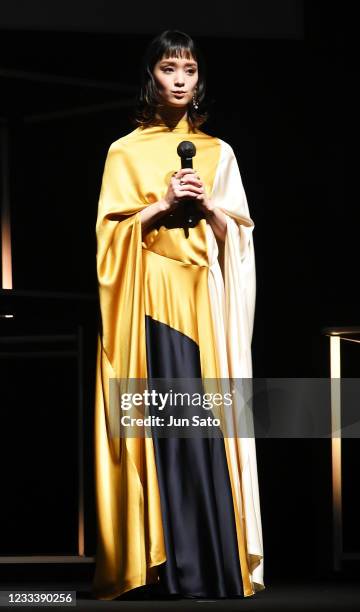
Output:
[{"xmin": 153, "ymin": 52, "xmax": 199, "ymax": 108}]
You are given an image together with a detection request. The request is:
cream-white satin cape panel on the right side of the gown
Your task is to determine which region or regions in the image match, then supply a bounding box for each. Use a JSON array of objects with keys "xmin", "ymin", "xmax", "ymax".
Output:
[{"xmin": 207, "ymin": 140, "xmax": 264, "ymax": 591}]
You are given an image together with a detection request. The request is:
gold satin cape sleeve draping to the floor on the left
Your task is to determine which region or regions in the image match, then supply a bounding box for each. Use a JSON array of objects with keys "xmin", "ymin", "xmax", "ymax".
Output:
[{"xmin": 93, "ymin": 139, "xmax": 166, "ymax": 599}]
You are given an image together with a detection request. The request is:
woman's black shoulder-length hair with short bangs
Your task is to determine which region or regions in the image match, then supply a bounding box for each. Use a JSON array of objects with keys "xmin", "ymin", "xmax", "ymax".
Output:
[{"xmin": 133, "ymin": 30, "xmax": 208, "ymax": 130}]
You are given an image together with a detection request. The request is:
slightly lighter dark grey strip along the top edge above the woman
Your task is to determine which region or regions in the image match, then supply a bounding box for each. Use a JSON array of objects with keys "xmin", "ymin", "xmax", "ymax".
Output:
[{"xmin": 0, "ymin": 0, "xmax": 303, "ymax": 38}]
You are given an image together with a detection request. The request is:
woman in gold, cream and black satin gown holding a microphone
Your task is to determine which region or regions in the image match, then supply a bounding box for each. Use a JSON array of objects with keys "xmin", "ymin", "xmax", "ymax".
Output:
[{"xmin": 93, "ymin": 31, "xmax": 264, "ymax": 599}]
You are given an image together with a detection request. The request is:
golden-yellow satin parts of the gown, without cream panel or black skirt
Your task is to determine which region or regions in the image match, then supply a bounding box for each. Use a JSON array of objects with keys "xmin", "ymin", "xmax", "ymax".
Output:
[{"xmin": 93, "ymin": 119, "xmax": 260, "ymax": 599}]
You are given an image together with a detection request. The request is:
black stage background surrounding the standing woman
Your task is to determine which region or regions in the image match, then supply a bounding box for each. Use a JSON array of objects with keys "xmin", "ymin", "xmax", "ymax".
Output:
[{"xmin": 0, "ymin": 1, "xmax": 354, "ymax": 584}]
